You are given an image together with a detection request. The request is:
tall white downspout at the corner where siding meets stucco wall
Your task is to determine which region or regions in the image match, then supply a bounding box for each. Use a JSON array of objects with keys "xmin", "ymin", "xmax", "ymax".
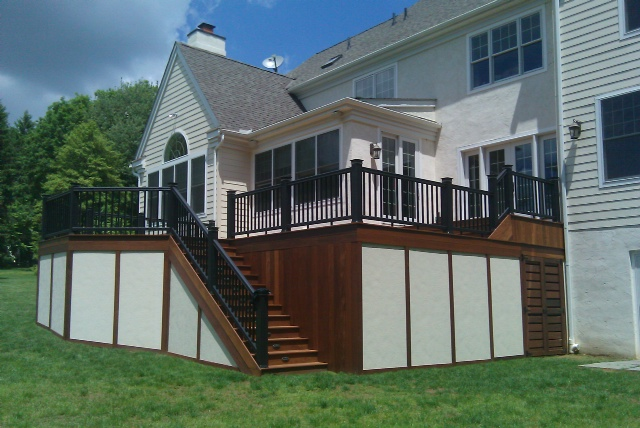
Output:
[{"xmin": 552, "ymin": 0, "xmax": 579, "ymax": 353}]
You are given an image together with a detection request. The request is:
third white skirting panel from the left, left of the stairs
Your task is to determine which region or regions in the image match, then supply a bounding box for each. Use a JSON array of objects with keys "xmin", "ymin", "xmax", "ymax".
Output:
[{"xmin": 69, "ymin": 251, "xmax": 116, "ymax": 343}]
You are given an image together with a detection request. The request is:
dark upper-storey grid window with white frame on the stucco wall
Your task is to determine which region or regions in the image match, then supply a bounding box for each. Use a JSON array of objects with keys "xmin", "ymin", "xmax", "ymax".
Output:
[{"xmin": 470, "ymin": 12, "xmax": 543, "ymax": 89}]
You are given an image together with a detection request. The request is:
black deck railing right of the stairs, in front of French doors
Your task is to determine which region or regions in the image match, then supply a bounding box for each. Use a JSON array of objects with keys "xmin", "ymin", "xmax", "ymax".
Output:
[{"xmin": 227, "ymin": 159, "xmax": 560, "ymax": 238}]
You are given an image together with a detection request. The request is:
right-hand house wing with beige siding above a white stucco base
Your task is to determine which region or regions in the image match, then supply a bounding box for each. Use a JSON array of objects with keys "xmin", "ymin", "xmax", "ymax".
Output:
[{"xmin": 557, "ymin": 0, "xmax": 640, "ymax": 358}]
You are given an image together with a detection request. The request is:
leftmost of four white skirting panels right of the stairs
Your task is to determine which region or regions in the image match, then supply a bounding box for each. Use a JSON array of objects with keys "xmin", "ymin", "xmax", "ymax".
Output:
[{"xmin": 362, "ymin": 245, "xmax": 407, "ymax": 370}]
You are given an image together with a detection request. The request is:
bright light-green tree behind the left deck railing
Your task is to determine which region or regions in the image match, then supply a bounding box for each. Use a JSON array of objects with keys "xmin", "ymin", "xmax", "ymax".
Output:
[{"xmin": 44, "ymin": 121, "xmax": 122, "ymax": 194}]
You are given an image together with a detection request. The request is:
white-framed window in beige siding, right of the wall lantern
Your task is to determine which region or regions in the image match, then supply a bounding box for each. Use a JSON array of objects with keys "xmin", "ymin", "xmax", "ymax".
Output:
[{"xmin": 596, "ymin": 88, "xmax": 640, "ymax": 182}]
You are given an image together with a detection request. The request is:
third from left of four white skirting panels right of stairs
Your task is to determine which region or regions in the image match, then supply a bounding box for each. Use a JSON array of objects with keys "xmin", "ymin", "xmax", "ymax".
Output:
[{"xmin": 452, "ymin": 254, "xmax": 491, "ymax": 361}]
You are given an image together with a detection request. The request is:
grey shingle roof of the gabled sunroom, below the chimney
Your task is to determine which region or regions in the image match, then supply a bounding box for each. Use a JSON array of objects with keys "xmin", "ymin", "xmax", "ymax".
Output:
[{"xmin": 178, "ymin": 43, "xmax": 304, "ymax": 131}]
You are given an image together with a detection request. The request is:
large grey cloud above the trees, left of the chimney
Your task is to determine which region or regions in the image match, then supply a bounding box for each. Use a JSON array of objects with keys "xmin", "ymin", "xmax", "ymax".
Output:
[{"xmin": 0, "ymin": 0, "xmax": 192, "ymax": 120}]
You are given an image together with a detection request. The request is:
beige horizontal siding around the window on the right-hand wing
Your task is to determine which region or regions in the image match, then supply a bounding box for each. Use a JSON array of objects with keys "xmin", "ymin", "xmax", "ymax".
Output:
[{"xmin": 560, "ymin": 0, "xmax": 640, "ymax": 231}]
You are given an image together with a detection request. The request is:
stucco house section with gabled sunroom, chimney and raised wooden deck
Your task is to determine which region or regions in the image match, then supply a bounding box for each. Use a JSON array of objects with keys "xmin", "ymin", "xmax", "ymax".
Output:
[{"xmin": 37, "ymin": 0, "xmax": 568, "ymax": 374}]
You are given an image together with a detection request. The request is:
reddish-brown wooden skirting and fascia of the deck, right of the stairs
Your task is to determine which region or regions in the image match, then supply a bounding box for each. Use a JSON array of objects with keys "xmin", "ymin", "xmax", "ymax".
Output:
[{"xmin": 234, "ymin": 216, "xmax": 564, "ymax": 373}]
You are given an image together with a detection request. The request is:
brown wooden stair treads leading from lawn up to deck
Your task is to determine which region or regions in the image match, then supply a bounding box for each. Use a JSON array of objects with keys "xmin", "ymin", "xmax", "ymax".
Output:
[{"xmin": 220, "ymin": 240, "xmax": 327, "ymax": 373}]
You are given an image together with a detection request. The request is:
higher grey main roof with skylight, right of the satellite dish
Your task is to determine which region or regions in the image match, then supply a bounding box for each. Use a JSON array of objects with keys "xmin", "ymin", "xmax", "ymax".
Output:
[{"xmin": 287, "ymin": 0, "xmax": 495, "ymax": 89}]
